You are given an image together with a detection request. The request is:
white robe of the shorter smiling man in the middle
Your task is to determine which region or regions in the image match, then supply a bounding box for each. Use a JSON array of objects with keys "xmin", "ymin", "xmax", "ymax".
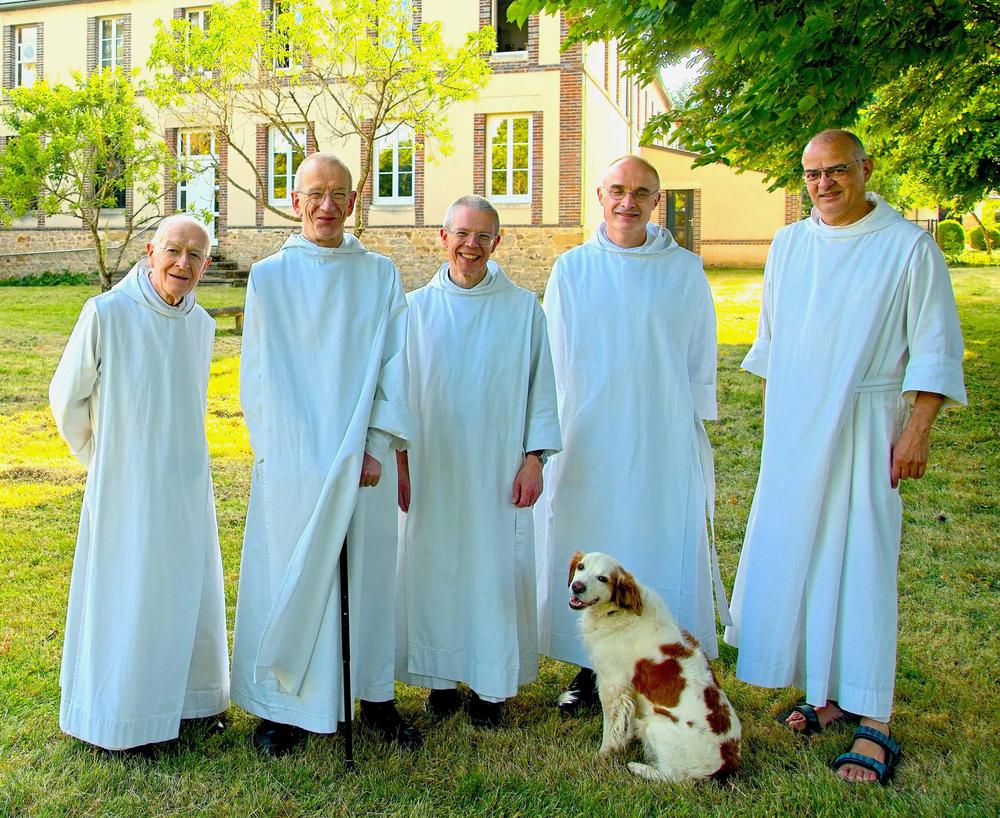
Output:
[{"xmin": 396, "ymin": 262, "xmax": 562, "ymax": 699}]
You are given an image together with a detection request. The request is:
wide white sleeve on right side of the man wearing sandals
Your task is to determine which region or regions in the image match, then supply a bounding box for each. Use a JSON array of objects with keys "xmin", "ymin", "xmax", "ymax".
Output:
[{"xmin": 903, "ymin": 237, "xmax": 968, "ymax": 408}]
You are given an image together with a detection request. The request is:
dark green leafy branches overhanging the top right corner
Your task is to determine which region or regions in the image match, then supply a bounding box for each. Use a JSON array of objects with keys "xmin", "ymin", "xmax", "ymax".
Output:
[{"xmin": 513, "ymin": 0, "xmax": 1000, "ymax": 209}]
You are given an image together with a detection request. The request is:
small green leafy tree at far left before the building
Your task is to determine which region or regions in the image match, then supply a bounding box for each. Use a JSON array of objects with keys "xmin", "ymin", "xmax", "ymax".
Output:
[{"xmin": 0, "ymin": 70, "xmax": 169, "ymax": 290}]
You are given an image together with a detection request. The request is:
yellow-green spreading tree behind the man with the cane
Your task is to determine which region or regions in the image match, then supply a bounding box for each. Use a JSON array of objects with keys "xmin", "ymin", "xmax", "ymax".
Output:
[{"xmin": 149, "ymin": 0, "xmax": 495, "ymax": 235}]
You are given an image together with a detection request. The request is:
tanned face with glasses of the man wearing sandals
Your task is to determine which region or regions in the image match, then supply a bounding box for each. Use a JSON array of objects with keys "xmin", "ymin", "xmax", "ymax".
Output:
[{"xmin": 802, "ymin": 136, "xmax": 874, "ymax": 227}]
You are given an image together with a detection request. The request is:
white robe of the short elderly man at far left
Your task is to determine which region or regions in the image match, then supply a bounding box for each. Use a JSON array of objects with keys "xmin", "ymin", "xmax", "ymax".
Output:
[{"xmin": 49, "ymin": 263, "xmax": 229, "ymax": 750}]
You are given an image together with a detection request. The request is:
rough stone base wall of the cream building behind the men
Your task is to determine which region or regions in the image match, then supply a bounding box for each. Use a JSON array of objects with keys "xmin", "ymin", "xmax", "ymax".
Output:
[{"xmin": 0, "ymin": 227, "xmax": 584, "ymax": 293}]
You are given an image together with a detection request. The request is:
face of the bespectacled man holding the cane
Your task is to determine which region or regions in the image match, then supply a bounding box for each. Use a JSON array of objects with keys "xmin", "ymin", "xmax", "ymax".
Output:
[{"xmin": 292, "ymin": 157, "xmax": 357, "ymax": 247}]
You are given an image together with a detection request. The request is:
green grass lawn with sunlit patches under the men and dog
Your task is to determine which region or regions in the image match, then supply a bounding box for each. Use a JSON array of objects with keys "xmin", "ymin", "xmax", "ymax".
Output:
[{"xmin": 0, "ymin": 268, "xmax": 1000, "ymax": 818}]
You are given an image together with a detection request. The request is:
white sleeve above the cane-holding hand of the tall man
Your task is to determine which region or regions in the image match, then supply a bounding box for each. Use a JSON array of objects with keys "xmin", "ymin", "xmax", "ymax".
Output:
[{"xmin": 365, "ymin": 269, "xmax": 415, "ymax": 450}]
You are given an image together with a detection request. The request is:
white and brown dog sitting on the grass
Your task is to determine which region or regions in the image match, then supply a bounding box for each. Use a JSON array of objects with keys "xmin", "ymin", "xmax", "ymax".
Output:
[{"xmin": 569, "ymin": 551, "xmax": 742, "ymax": 781}]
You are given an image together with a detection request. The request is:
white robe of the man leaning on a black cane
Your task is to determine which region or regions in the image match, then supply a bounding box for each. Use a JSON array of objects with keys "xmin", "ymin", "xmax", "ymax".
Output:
[{"xmin": 233, "ymin": 235, "xmax": 412, "ymax": 733}]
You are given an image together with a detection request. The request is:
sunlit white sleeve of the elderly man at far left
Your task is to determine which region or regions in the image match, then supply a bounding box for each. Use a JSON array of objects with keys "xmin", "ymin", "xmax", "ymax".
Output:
[{"xmin": 49, "ymin": 299, "xmax": 101, "ymax": 466}]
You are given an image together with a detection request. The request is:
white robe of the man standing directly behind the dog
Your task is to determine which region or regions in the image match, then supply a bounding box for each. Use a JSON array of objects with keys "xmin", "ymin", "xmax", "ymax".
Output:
[{"xmin": 535, "ymin": 224, "xmax": 728, "ymax": 665}]
